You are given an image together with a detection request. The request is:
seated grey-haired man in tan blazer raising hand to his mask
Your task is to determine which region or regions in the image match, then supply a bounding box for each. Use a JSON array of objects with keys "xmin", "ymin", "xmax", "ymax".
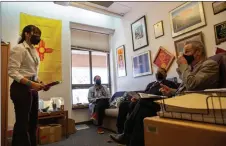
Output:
[{"xmin": 110, "ymin": 41, "xmax": 219, "ymax": 146}]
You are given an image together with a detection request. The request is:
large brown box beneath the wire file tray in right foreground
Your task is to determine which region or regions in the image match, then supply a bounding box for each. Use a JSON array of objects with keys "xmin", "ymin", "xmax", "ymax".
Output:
[{"xmin": 144, "ymin": 116, "xmax": 226, "ymax": 146}]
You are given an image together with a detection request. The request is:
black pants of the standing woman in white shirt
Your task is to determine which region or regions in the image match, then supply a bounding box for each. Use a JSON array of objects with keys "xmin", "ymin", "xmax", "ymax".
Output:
[{"xmin": 10, "ymin": 81, "xmax": 38, "ymax": 146}]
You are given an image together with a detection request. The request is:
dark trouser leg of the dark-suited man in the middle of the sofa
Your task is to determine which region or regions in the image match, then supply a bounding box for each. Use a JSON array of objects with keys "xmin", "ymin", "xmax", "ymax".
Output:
[{"xmin": 116, "ymin": 101, "xmax": 137, "ymax": 133}]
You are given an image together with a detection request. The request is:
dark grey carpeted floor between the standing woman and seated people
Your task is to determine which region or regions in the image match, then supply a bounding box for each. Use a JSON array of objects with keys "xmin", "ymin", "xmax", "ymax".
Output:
[{"xmin": 42, "ymin": 125, "xmax": 121, "ymax": 146}]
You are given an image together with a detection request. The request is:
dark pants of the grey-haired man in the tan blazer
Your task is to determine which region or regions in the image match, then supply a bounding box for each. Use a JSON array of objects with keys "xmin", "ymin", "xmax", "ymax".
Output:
[{"xmin": 124, "ymin": 99, "xmax": 160, "ymax": 146}]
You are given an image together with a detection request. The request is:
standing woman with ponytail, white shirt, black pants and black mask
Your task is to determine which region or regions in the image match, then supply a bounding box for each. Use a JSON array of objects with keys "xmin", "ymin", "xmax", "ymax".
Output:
[{"xmin": 8, "ymin": 25, "xmax": 48, "ymax": 146}]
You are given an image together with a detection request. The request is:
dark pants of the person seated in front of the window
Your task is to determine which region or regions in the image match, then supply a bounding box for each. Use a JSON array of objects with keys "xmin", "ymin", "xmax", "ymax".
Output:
[{"xmin": 94, "ymin": 99, "xmax": 109, "ymax": 126}]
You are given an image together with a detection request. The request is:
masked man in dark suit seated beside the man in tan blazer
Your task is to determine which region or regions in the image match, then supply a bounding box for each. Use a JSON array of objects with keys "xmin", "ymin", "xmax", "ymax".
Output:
[{"xmin": 116, "ymin": 68, "xmax": 178, "ymax": 133}]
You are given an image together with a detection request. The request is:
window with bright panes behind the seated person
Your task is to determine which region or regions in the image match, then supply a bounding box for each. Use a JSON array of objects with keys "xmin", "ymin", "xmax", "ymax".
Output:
[{"xmin": 72, "ymin": 49, "xmax": 111, "ymax": 107}]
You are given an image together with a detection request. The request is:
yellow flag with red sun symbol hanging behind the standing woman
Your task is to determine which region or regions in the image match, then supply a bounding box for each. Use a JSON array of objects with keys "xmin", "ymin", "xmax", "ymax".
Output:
[{"xmin": 20, "ymin": 13, "xmax": 62, "ymax": 83}]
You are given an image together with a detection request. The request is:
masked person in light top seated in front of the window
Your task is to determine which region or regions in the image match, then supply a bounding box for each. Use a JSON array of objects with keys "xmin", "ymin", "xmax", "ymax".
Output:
[{"xmin": 88, "ymin": 75, "xmax": 110, "ymax": 134}]
